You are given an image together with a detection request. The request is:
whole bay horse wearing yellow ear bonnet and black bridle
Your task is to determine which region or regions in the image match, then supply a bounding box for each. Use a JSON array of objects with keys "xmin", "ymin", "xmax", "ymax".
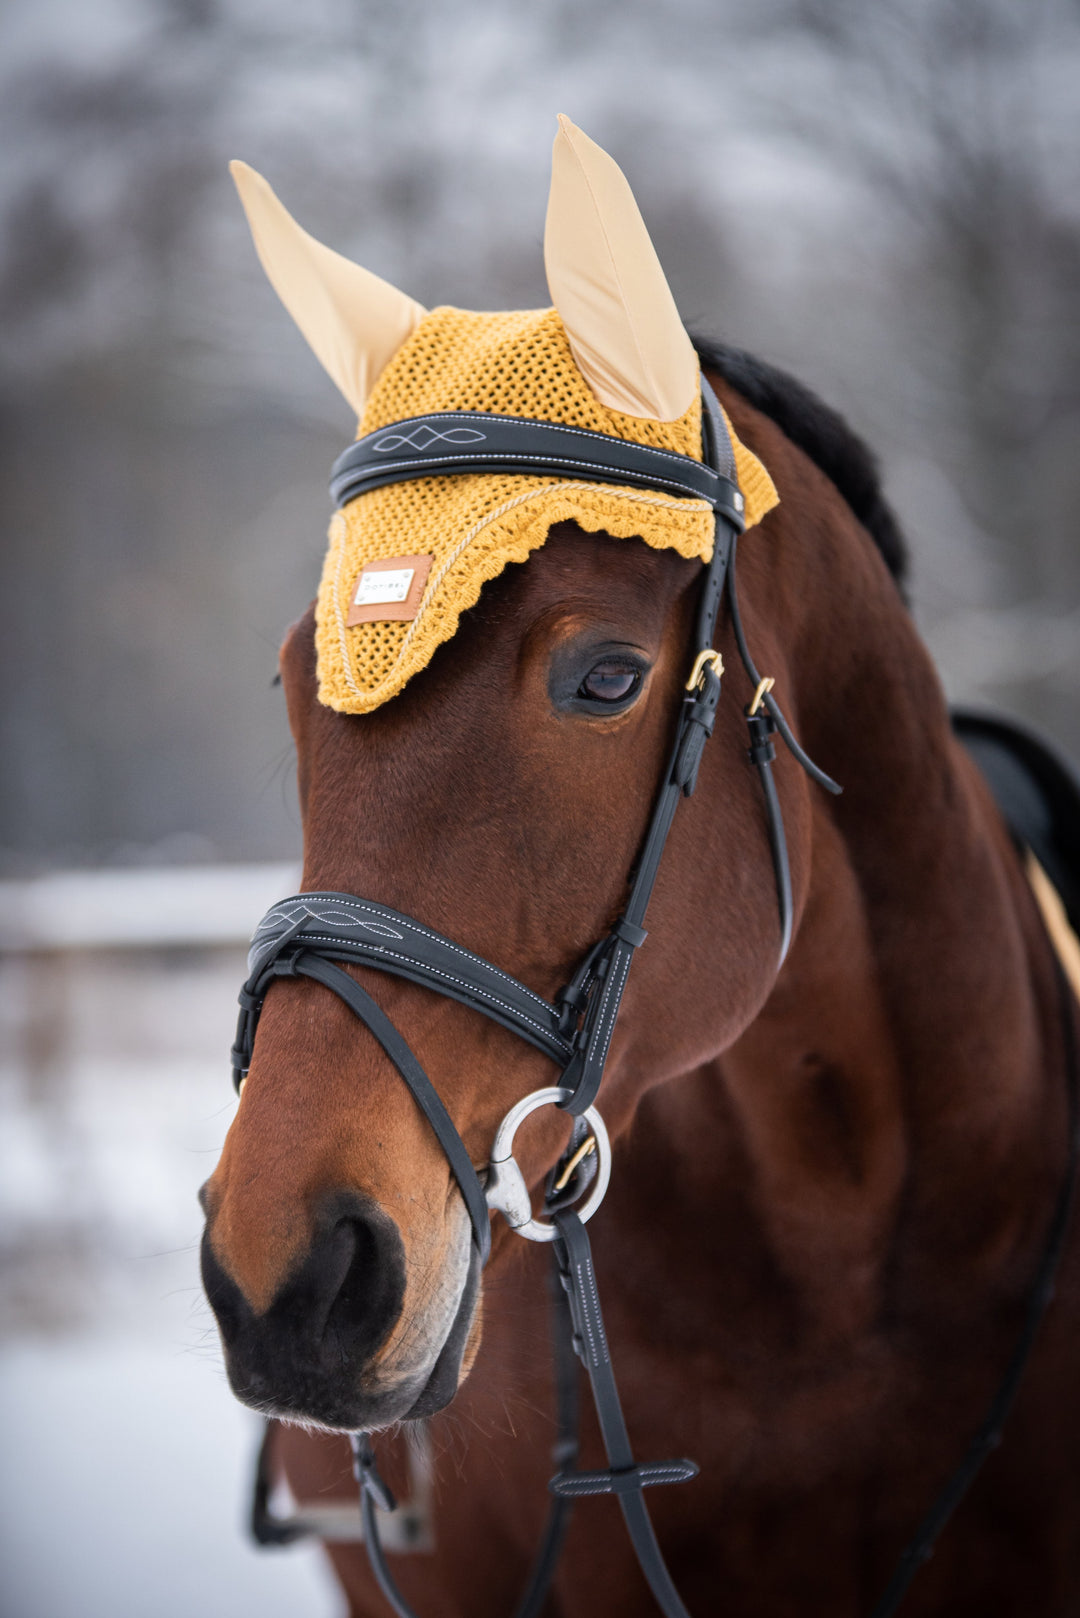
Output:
[{"xmin": 194, "ymin": 120, "xmax": 1080, "ymax": 1618}]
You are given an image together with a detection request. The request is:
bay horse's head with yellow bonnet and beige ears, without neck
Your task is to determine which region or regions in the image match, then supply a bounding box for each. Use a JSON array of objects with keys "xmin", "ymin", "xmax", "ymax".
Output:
[{"xmin": 202, "ymin": 120, "xmax": 829, "ymax": 1430}]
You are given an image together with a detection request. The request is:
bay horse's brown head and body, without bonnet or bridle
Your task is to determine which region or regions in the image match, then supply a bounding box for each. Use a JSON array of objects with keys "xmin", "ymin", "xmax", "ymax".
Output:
[{"xmin": 202, "ymin": 119, "xmax": 1080, "ymax": 1618}]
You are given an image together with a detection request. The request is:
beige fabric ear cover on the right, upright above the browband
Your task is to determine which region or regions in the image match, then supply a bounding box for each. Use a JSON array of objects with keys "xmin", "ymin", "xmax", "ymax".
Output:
[{"xmin": 544, "ymin": 115, "xmax": 699, "ymax": 421}]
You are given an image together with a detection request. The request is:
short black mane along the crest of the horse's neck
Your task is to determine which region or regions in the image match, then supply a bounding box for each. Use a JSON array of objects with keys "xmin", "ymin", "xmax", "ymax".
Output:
[{"xmin": 693, "ymin": 337, "xmax": 908, "ymax": 591}]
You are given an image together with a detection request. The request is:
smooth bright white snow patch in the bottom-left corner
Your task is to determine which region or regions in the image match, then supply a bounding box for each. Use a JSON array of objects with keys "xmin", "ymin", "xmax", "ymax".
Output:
[{"xmin": 0, "ymin": 1309, "xmax": 343, "ymax": 1618}]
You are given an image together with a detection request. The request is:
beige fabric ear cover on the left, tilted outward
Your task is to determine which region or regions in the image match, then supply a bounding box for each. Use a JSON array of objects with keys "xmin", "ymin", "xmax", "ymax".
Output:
[{"xmin": 228, "ymin": 163, "xmax": 427, "ymax": 416}]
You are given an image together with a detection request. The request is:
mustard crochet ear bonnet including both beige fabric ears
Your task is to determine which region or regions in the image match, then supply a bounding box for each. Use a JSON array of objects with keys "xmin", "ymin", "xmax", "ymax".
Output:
[{"xmin": 232, "ymin": 118, "xmax": 777, "ymax": 714}]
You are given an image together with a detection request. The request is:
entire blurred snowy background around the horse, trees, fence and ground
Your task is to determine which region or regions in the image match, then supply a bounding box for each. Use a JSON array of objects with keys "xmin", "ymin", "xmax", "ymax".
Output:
[{"xmin": 0, "ymin": 0, "xmax": 1080, "ymax": 1618}]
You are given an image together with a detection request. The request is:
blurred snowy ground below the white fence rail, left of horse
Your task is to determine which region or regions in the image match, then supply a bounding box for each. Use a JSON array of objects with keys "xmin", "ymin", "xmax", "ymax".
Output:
[{"xmin": 0, "ymin": 895, "xmax": 343, "ymax": 1618}]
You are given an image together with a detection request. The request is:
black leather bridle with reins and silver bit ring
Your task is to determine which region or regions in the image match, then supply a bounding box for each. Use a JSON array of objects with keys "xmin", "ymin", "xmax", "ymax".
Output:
[{"xmin": 233, "ymin": 380, "xmax": 1077, "ymax": 1618}]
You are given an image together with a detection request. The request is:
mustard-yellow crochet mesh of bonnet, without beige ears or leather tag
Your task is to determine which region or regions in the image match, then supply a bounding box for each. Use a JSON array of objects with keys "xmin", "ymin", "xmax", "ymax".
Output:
[{"xmin": 316, "ymin": 309, "xmax": 777, "ymax": 714}]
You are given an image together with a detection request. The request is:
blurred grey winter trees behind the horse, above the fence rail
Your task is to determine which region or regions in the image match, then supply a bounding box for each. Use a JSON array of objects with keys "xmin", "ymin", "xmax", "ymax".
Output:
[{"xmin": 0, "ymin": 0, "xmax": 1080, "ymax": 864}]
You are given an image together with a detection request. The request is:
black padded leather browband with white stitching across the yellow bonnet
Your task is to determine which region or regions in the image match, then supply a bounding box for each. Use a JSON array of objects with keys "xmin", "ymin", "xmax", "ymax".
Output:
[{"xmin": 330, "ymin": 411, "xmax": 743, "ymax": 527}]
